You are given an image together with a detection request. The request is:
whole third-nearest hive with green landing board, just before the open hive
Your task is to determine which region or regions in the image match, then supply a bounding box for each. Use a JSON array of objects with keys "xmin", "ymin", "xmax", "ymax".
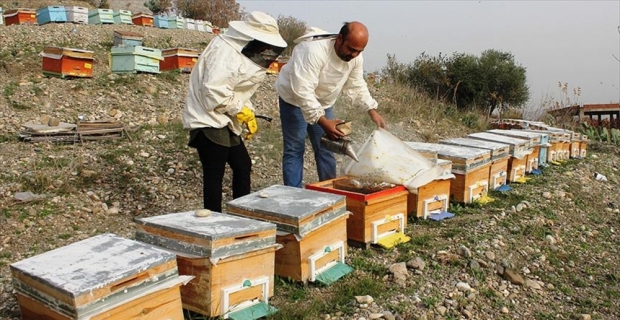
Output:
[{"xmin": 226, "ymin": 185, "xmax": 351, "ymax": 284}]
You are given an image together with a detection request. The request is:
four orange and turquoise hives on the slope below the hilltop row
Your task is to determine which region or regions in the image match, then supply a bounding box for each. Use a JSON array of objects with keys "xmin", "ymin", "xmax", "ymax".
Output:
[{"xmin": 40, "ymin": 31, "xmax": 199, "ymax": 78}]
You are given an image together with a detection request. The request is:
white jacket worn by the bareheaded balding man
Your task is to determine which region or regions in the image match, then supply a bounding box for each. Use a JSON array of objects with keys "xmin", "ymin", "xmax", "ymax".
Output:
[{"xmin": 276, "ymin": 38, "xmax": 378, "ymax": 124}]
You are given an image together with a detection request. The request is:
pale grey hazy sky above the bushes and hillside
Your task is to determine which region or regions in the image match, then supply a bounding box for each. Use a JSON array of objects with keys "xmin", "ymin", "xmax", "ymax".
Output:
[{"xmin": 237, "ymin": 0, "xmax": 620, "ymax": 104}]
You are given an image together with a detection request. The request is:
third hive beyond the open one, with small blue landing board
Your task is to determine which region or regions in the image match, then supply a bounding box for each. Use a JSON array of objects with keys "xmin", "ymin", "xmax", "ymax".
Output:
[{"xmin": 440, "ymin": 138, "xmax": 518, "ymax": 190}]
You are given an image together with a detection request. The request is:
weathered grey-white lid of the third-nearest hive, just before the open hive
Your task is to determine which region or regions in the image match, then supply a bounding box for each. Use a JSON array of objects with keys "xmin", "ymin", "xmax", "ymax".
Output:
[{"xmin": 226, "ymin": 185, "xmax": 346, "ymax": 236}]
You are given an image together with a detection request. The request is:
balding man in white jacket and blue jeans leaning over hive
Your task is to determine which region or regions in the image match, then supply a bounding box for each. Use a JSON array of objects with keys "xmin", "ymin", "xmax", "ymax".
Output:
[{"xmin": 276, "ymin": 22, "xmax": 386, "ymax": 188}]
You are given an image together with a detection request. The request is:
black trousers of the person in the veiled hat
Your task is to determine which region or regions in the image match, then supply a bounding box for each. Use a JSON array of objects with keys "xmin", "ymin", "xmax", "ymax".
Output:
[{"xmin": 195, "ymin": 132, "xmax": 252, "ymax": 212}]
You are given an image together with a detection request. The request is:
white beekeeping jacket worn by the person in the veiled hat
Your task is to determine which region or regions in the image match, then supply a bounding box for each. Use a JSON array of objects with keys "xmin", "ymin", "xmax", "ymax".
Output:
[{"xmin": 183, "ymin": 28, "xmax": 267, "ymax": 135}]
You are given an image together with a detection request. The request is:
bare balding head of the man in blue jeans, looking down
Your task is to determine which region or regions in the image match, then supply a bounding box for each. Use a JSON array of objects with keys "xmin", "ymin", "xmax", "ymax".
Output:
[{"xmin": 334, "ymin": 21, "xmax": 368, "ymax": 61}]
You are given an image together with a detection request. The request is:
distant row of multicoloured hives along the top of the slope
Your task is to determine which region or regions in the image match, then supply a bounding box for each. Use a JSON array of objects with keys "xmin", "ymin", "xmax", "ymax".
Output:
[{"xmin": 0, "ymin": 6, "xmax": 225, "ymax": 34}]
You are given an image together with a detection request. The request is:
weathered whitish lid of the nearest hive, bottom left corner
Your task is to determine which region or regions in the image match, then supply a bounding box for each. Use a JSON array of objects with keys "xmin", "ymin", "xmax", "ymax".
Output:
[{"xmin": 10, "ymin": 233, "xmax": 178, "ymax": 318}]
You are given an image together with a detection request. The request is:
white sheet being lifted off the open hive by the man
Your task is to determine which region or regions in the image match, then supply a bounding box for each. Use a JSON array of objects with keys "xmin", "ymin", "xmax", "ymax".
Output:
[{"xmin": 344, "ymin": 129, "xmax": 444, "ymax": 193}]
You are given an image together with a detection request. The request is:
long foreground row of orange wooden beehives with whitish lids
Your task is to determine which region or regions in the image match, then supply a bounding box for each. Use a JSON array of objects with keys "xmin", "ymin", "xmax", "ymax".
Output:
[{"xmin": 11, "ymin": 122, "xmax": 587, "ymax": 319}]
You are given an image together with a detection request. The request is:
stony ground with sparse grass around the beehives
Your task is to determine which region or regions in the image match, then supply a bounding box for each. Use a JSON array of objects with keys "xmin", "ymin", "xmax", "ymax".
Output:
[{"xmin": 0, "ymin": 3, "xmax": 620, "ymax": 320}]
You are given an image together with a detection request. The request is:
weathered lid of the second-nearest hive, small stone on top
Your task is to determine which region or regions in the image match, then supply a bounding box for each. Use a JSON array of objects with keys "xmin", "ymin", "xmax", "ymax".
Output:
[{"xmin": 136, "ymin": 211, "xmax": 276, "ymax": 258}]
